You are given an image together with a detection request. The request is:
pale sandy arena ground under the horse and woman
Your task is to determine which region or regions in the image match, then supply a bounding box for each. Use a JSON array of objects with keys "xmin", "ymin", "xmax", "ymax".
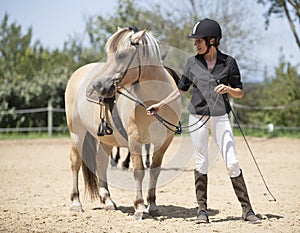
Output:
[{"xmin": 0, "ymin": 137, "xmax": 300, "ymax": 233}]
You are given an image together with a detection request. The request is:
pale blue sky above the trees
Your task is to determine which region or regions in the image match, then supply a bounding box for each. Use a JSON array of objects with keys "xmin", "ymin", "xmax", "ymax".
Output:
[{"xmin": 0, "ymin": 0, "xmax": 300, "ymax": 82}]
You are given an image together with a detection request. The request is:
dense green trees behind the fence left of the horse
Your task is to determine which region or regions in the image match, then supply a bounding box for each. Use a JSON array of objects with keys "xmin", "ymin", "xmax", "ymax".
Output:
[{"xmin": 0, "ymin": 15, "xmax": 76, "ymax": 128}]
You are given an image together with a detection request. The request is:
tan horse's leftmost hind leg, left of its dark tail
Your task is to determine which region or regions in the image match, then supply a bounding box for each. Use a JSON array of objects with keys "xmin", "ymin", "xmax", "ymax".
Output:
[{"xmin": 70, "ymin": 143, "xmax": 83, "ymax": 212}]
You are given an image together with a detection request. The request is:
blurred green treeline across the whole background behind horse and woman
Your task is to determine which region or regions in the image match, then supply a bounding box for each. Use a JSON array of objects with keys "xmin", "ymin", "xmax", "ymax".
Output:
[{"xmin": 0, "ymin": 0, "xmax": 300, "ymax": 133}]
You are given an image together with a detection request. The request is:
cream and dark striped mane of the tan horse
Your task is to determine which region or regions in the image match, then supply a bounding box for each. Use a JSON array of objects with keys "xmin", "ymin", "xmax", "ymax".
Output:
[{"xmin": 106, "ymin": 28, "xmax": 162, "ymax": 64}]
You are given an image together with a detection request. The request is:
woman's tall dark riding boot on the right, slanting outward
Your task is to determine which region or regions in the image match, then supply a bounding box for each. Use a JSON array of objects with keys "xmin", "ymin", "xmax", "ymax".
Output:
[{"xmin": 230, "ymin": 170, "xmax": 260, "ymax": 223}]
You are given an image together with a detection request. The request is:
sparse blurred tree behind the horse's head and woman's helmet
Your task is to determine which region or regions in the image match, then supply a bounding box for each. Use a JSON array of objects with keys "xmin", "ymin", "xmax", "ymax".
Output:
[{"xmin": 82, "ymin": 0, "xmax": 258, "ymax": 82}]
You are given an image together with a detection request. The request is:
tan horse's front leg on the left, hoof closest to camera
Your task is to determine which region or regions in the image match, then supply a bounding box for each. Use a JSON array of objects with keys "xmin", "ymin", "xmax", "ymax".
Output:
[{"xmin": 131, "ymin": 153, "xmax": 149, "ymax": 220}]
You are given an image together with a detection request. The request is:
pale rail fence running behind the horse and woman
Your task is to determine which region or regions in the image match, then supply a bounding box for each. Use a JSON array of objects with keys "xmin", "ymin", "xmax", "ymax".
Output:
[{"xmin": 0, "ymin": 101, "xmax": 300, "ymax": 136}]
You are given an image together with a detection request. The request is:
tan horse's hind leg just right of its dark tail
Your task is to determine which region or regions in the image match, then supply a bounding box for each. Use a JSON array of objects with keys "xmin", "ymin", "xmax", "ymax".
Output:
[{"xmin": 97, "ymin": 143, "xmax": 116, "ymax": 210}]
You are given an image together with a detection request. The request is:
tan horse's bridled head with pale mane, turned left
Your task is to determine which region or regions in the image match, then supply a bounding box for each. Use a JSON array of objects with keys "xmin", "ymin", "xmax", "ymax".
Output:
[{"xmin": 93, "ymin": 27, "xmax": 161, "ymax": 98}]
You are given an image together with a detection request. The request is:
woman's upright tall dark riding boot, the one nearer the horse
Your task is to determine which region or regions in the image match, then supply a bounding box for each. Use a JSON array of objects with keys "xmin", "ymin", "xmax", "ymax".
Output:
[{"xmin": 194, "ymin": 170, "xmax": 209, "ymax": 224}]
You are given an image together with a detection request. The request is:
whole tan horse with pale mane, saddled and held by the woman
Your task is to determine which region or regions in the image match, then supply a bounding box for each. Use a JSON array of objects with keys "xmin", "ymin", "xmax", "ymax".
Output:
[{"xmin": 65, "ymin": 27, "xmax": 181, "ymax": 219}]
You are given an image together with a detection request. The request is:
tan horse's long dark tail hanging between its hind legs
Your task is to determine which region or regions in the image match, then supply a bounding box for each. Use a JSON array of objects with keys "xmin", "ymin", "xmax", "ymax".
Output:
[{"xmin": 82, "ymin": 132, "xmax": 99, "ymax": 200}]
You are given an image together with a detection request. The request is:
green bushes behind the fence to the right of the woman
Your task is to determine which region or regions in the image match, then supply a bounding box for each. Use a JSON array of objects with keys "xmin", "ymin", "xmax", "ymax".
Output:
[{"xmin": 238, "ymin": 56, "xmax": 300, "ymax": 127}]
